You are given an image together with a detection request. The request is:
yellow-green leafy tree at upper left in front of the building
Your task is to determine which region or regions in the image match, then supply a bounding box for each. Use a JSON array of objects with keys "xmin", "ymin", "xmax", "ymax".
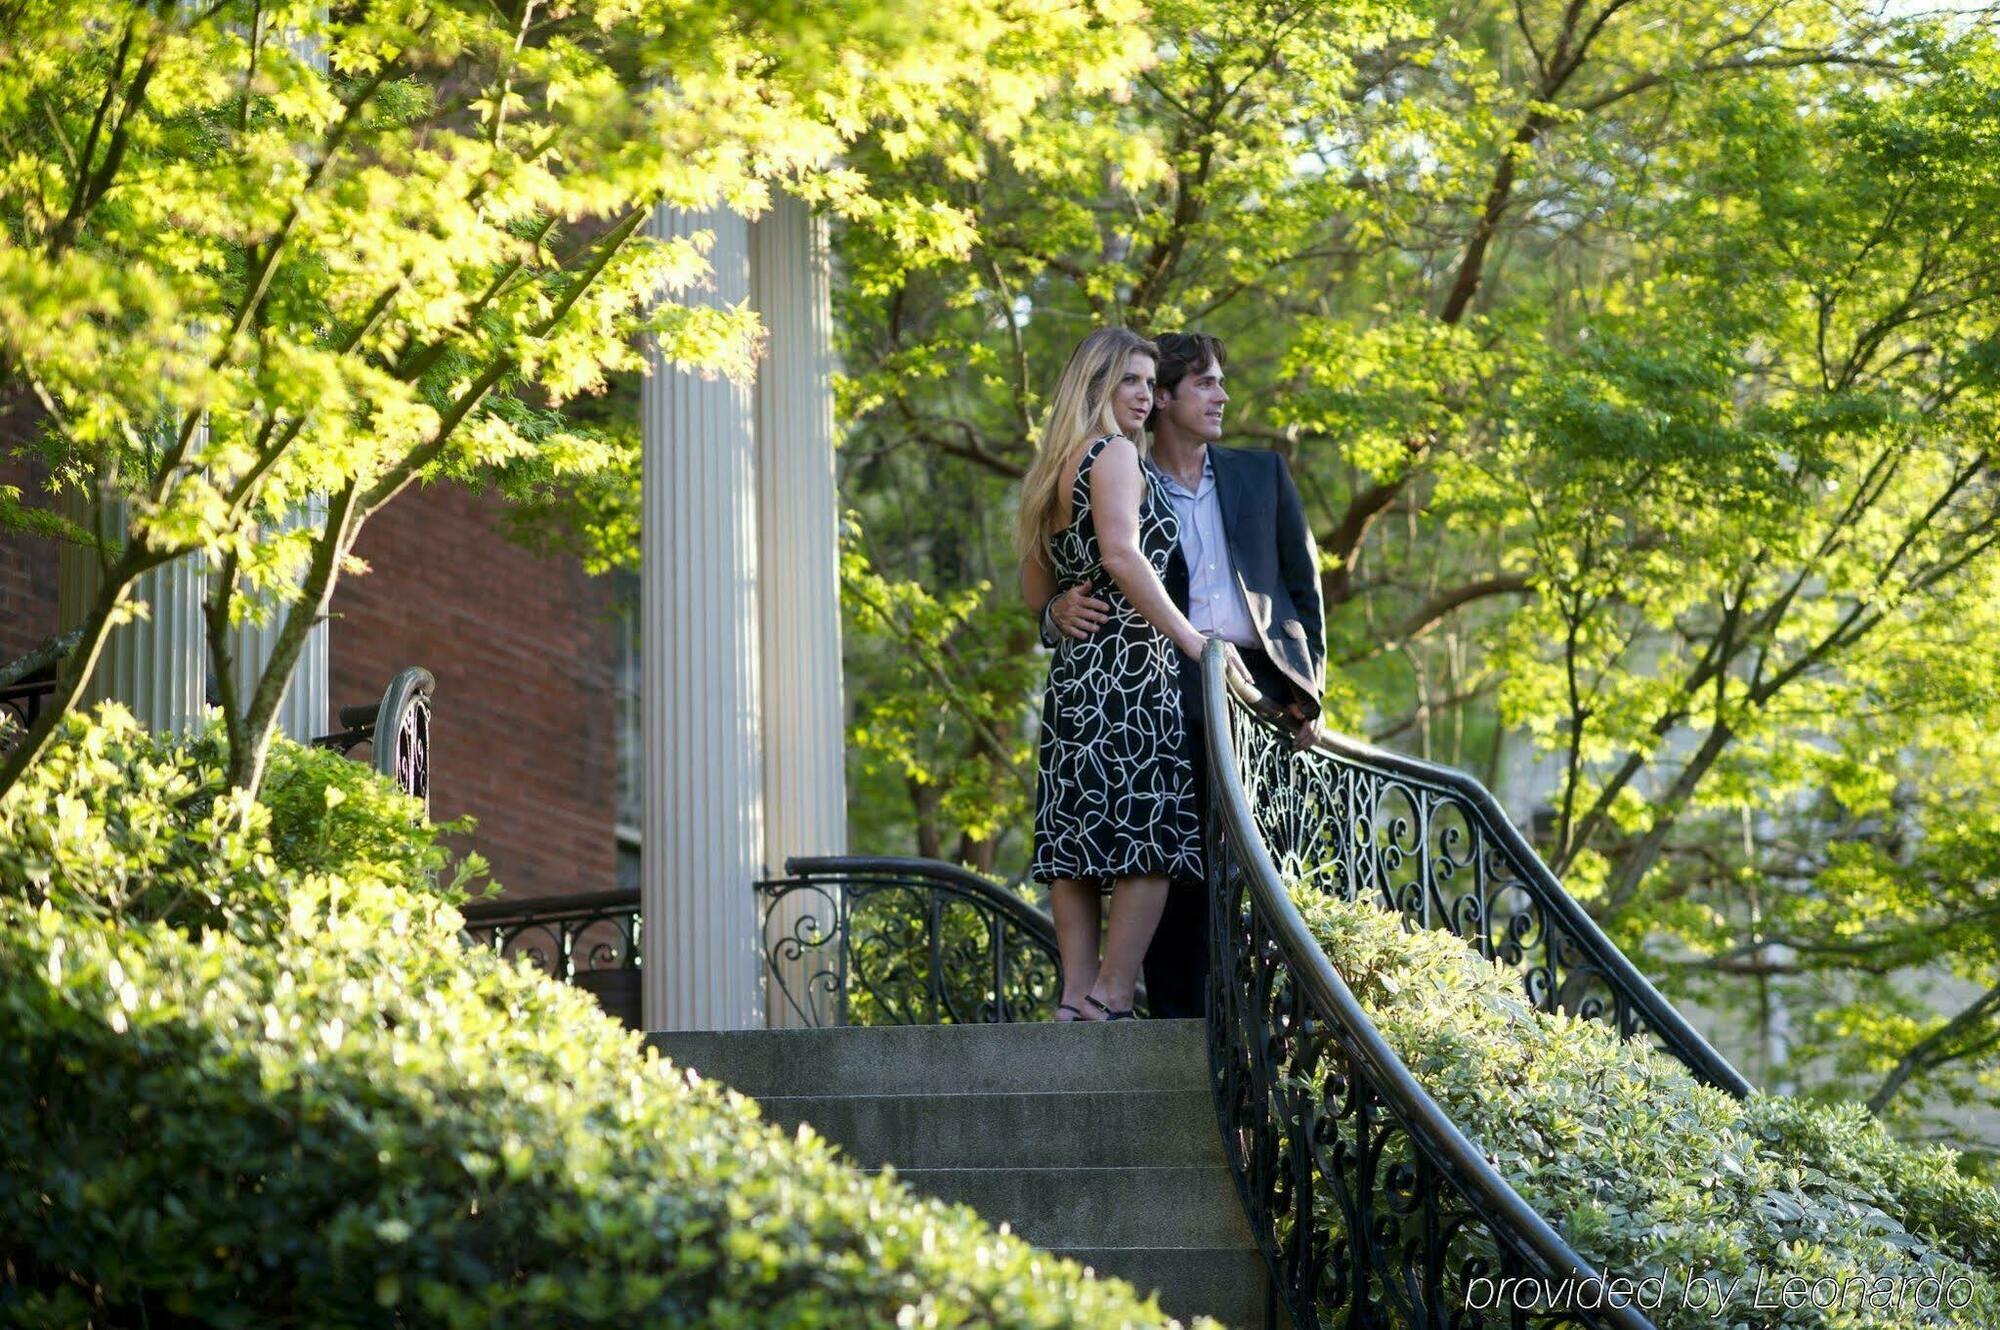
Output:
[{"xmin": 0, "ymin": 0, "xmax": 1138, "ymax": 790}]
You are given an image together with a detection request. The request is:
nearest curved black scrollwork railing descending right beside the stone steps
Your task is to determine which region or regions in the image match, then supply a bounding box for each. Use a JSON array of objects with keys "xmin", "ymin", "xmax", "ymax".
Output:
[{"xmin": 1202, "ymin": 642, "xmax": 1696, "ymax": 1330}]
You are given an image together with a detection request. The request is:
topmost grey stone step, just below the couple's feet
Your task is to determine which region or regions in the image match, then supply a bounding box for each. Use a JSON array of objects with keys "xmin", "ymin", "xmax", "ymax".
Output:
[{"xmin": 646, "ymin": 1020, "xmax": 1208, "ymax": 1098}]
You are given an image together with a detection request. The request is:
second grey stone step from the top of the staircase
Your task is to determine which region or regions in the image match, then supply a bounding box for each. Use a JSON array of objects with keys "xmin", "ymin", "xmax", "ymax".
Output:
[{"xmin": 758, "ymin": 1090, "xmax": 1224, "ymax": 1170}]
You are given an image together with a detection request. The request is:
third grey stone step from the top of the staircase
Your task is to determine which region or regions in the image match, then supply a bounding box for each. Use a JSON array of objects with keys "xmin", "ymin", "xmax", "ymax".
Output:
[{"xmin": 880, "ymin": 1166, "xmax": 1252, "ymax": 1250}]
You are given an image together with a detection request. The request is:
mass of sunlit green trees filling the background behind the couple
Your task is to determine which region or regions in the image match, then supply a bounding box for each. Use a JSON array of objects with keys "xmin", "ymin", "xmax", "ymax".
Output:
[{"xmin": 838, "ymin": 0, "xmax": 2000, "ymax": 1144}]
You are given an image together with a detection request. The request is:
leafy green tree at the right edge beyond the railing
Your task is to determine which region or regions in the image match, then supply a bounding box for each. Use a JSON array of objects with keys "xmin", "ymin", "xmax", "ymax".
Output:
[{"xmin": 1468, "ymin": 34, "xmax": 2000, "ymax": 1110}]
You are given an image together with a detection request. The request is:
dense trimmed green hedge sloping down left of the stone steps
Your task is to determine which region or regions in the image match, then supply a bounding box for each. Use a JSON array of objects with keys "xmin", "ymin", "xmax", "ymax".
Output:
[{"xmin": 0, "ymin": 710, "xmax": 1170, "ymax": 1330}]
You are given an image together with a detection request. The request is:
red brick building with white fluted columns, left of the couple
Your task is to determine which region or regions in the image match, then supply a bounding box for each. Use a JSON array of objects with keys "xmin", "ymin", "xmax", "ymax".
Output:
[{"xmin": 0, "ymin": 200, "xmax": 846, "ymax": 1030}]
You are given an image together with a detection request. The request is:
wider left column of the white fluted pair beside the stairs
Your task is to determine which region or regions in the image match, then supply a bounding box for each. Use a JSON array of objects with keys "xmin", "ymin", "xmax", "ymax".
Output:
[{"xmin": 640, "ymin": 210, "xmax": 764, "ymax": 1030}]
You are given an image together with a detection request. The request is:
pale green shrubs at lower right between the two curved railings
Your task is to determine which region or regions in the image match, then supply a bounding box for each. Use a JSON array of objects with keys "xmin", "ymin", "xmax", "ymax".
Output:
[{"xmin": 1294, "ymin": 890, "xmax": 2000, "ymax": 1330}]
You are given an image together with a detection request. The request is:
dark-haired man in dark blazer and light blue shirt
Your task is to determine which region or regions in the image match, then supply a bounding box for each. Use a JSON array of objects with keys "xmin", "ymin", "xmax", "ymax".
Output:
[{"xmin": 1042, "ymin": 332, "xmax": 1326, "ymax": 1016}]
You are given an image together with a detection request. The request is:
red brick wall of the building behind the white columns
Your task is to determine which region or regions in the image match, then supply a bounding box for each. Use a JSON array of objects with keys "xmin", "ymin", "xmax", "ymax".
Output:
[{"xmin": 0, "ymin": 456, "xmax": 618, "ymax": 896}]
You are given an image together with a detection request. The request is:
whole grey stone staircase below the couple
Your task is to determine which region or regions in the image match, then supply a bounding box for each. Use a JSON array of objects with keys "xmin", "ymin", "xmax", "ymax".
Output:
[{"xmin": 652, "ymin": 1020, "xmax": 1266, "ymax": 1330}]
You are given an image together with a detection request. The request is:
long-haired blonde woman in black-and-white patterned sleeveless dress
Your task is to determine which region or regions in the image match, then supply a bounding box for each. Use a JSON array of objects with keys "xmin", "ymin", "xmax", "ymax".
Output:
[{"xmin": 1014, "ymin": 328, "xmax": 1202, "ymax": 1020}]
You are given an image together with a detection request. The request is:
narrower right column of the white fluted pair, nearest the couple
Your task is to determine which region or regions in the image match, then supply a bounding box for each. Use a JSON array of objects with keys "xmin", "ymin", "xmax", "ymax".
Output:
[{"xmin": 750, "ymin": 196, "xmax": 848, "ymax": 1026}]
